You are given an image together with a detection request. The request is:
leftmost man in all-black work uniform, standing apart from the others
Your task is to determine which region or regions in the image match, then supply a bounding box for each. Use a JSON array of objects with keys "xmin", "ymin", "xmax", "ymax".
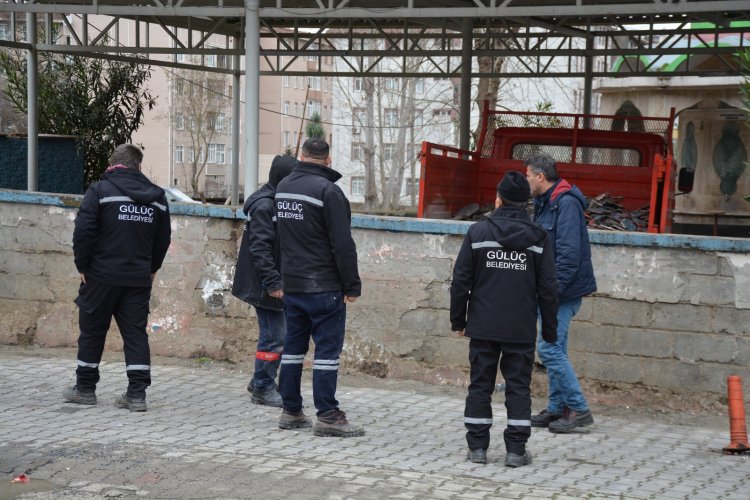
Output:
[{"xmin": 63, "ymin": 144, "xmax": 171, "ymax": 411}]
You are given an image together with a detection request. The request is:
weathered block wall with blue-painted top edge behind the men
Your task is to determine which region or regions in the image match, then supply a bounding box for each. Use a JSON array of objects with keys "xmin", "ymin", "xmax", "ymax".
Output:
[{"xmin": 0, "ymin": 191, "xmax": 750, "ymax": 392}]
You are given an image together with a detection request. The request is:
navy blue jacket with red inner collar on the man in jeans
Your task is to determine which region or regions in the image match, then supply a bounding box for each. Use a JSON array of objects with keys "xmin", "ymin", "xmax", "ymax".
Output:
[{"xmin": 534, "ymin": 179, "xmax": 596, "ymax": 302}]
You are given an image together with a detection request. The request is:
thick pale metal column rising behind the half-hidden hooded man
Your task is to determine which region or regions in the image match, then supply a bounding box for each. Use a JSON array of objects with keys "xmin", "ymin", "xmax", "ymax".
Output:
[{"xmin": 244, "ymin": 0, "xmax": 260, "ymax": 199}]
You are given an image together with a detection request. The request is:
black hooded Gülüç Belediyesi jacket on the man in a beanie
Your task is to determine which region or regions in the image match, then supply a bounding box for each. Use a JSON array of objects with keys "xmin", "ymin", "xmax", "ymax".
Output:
[{"xmin": 450, "ymin": 207, "xmax": 557, "ymax": 343}]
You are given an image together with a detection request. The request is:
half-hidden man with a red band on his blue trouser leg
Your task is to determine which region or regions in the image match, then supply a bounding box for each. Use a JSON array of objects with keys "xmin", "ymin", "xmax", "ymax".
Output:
[{"xmin": 232, "ymin": 156, "xmax": 297, "ymax": 408}]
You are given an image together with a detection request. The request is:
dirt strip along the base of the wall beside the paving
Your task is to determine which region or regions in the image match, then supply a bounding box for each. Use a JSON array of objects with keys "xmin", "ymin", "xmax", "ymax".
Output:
[{"xmin": 0, "ymin": 346, "xmax": 736, "ymax": 428}]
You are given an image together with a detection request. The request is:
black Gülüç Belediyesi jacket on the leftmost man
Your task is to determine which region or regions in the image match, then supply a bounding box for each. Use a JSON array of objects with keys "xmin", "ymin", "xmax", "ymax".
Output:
[{"xmin": 73, "ymin": 169, "xmax": 171, "ymax": 286}]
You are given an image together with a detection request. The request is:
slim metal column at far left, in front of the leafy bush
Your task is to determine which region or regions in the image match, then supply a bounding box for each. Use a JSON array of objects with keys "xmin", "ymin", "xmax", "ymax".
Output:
[{"xmin": 26, "ymin": 12, "xmax": 39, "ymax": 191}]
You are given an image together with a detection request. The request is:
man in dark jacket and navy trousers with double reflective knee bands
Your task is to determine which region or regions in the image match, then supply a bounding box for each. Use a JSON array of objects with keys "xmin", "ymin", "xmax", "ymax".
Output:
[{"xmin": 276, "ymin": 137, "xmax": 364, "ymax": 437}]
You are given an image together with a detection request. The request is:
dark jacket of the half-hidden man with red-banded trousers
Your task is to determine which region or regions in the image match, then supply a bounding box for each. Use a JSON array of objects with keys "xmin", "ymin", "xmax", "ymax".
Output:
[{"xmin": 232, "ymin": 184, "xmax": 284, "ymax": 311}]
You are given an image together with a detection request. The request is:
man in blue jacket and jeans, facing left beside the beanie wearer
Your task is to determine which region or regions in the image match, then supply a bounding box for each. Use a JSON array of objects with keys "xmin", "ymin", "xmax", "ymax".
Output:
[{"xmin": 525, "ymin": 155, "xmax": 596, "ymax": 433}]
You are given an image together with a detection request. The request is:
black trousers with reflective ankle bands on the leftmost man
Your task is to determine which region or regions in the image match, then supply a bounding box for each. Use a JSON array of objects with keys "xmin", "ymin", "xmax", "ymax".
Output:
[{"xmin": 76, "ymin": 280, "xmax": 151, "ymax": 398}]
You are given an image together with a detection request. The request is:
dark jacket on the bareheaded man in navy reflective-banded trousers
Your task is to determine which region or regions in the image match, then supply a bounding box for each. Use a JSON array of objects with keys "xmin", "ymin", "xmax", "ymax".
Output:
[{"xmin": 275, "ymin": 162, "xmax": 362, "ymax": 297}]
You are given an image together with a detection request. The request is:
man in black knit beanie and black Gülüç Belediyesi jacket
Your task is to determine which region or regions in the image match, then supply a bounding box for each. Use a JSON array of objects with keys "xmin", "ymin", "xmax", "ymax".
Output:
[{"xmin": 450, "ymin": 171, "xmax": 557, "ymax": 467}]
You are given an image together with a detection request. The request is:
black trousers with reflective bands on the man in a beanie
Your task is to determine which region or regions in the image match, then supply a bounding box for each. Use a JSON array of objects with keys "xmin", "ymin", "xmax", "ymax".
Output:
[{"xmin": 464, "ymin": 339, "xmax": 534, "ymax": 455}]
